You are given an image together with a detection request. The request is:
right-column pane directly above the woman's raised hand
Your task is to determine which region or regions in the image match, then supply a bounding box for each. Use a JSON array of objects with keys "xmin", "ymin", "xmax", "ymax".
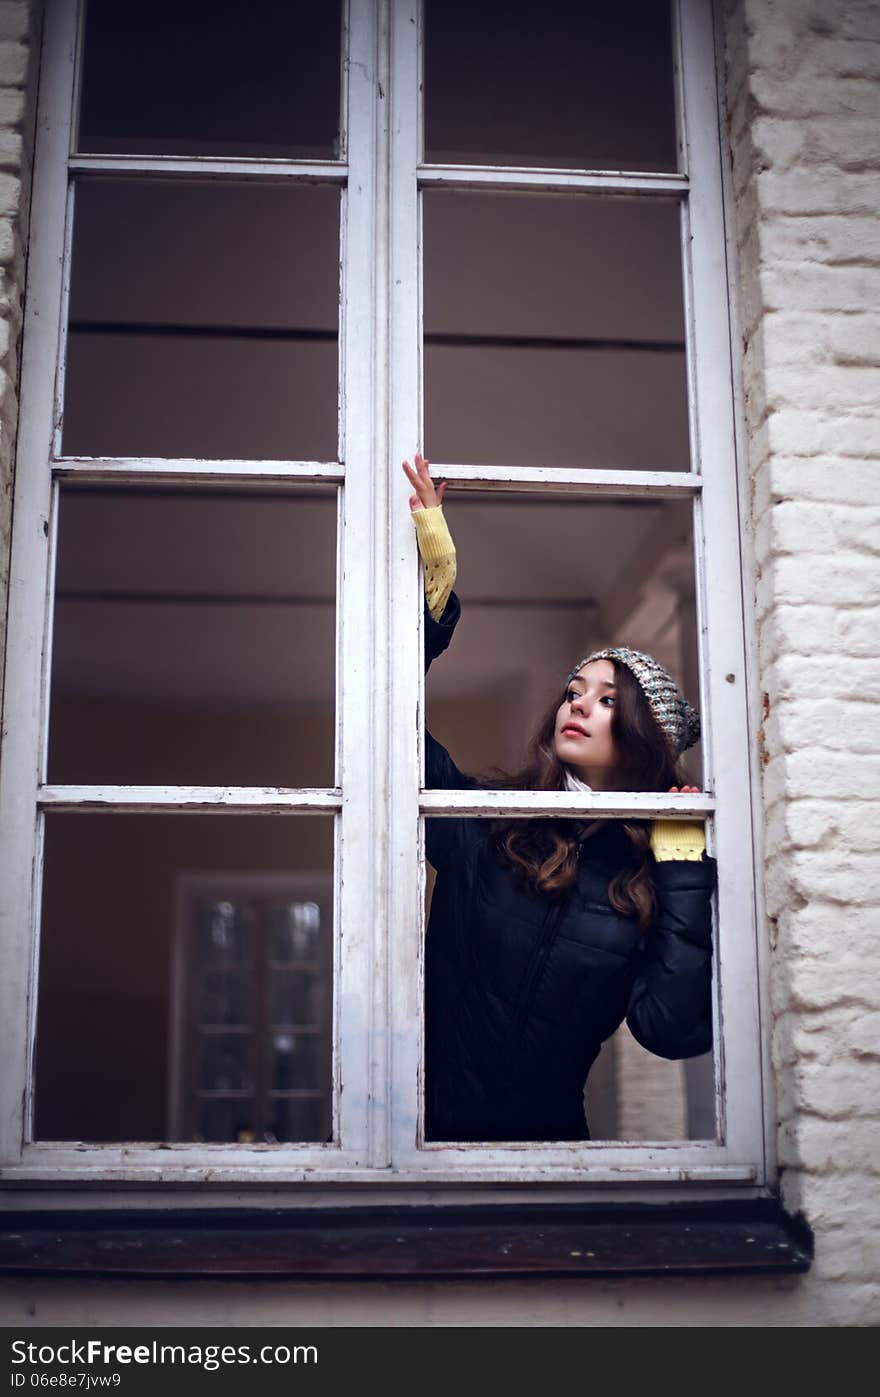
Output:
[{"xmin": 423, "ymin": 190, "xmax": 690, "ymax": 471}]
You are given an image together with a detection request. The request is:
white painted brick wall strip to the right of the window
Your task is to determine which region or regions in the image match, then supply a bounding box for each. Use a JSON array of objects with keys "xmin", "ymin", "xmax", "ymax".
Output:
[{"xmin": 726, "ymin": 0, "xmax": 880, "ymax": 1323}]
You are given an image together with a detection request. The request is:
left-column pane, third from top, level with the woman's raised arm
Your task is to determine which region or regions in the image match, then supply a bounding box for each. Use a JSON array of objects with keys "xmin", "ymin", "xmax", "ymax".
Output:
[{"xmin": 49, "ymin": 488, "xmax": 337, "ymax": 787}]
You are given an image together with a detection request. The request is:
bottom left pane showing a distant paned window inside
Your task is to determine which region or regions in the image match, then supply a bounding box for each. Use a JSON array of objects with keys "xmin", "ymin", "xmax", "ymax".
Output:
[{"xmin": 36, "ymin": 813, "xmax": 332, "ymax": 1143}]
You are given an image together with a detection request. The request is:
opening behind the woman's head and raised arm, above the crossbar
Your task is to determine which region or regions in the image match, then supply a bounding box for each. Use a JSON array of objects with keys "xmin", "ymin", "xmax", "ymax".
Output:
[{"xmin": 427, "ymin": 488, "xmax": 703, "ymax": 785}]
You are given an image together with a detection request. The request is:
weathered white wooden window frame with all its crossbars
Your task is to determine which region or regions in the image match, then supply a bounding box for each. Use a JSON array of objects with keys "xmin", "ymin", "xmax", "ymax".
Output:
[{"xmin": 0, "ymin": 0, "xmax": 772, "ymax": 1199}]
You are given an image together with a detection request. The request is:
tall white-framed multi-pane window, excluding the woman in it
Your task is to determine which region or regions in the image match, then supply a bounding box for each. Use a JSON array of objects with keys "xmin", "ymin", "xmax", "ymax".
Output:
[{"xmin": 0, "ymin": 0, "xmax": 765, "ymax": 1196}]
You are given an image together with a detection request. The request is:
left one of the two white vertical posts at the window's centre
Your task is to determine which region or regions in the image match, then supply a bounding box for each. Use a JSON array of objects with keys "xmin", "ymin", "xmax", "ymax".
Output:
[{"xmin": 334, "ymin": 0, "xmax": 387, "ymax": 1165}]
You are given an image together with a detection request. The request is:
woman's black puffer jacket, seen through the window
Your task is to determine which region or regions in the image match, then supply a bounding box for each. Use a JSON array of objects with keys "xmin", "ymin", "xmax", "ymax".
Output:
[{"xmin": 425, "ymin": 594, "xmax": 715, "ymax": 1141}]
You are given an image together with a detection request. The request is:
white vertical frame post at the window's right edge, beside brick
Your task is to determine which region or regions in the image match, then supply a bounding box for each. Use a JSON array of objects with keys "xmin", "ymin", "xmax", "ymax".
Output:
[{"xmin": 679, "ymin": 0, "xmax": 763, "ymax": 1179}]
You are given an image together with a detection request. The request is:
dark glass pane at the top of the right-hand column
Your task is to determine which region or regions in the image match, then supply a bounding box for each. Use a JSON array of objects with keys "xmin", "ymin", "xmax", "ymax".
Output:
[{"xmin": 425, "ymin": 0, "xmax": 676, "ymax": 170}]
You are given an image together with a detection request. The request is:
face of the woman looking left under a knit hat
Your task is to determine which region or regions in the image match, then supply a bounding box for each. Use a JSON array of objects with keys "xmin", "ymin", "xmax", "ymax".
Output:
[{"xmin": 553, "ymin": 659, "xmax": 617, "ymax": 791}]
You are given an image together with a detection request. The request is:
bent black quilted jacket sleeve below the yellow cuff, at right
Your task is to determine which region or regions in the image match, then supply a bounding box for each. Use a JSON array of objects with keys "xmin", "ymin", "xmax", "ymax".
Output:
[{"xmin": 626, "ymin": 854, "xmax": 717, "ymax": 1058}]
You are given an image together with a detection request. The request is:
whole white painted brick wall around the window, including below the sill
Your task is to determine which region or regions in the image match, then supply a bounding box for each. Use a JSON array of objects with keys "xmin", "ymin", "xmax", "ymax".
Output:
[{"xmin": 0, "ymin": 0, "xmax": 880, "ymax": 1326}]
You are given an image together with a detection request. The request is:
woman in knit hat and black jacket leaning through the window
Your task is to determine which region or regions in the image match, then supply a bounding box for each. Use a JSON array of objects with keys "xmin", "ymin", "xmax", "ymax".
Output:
[{"xmin": 404, "ymin": 455, "xmax": 715, "ymax": 1141}]
